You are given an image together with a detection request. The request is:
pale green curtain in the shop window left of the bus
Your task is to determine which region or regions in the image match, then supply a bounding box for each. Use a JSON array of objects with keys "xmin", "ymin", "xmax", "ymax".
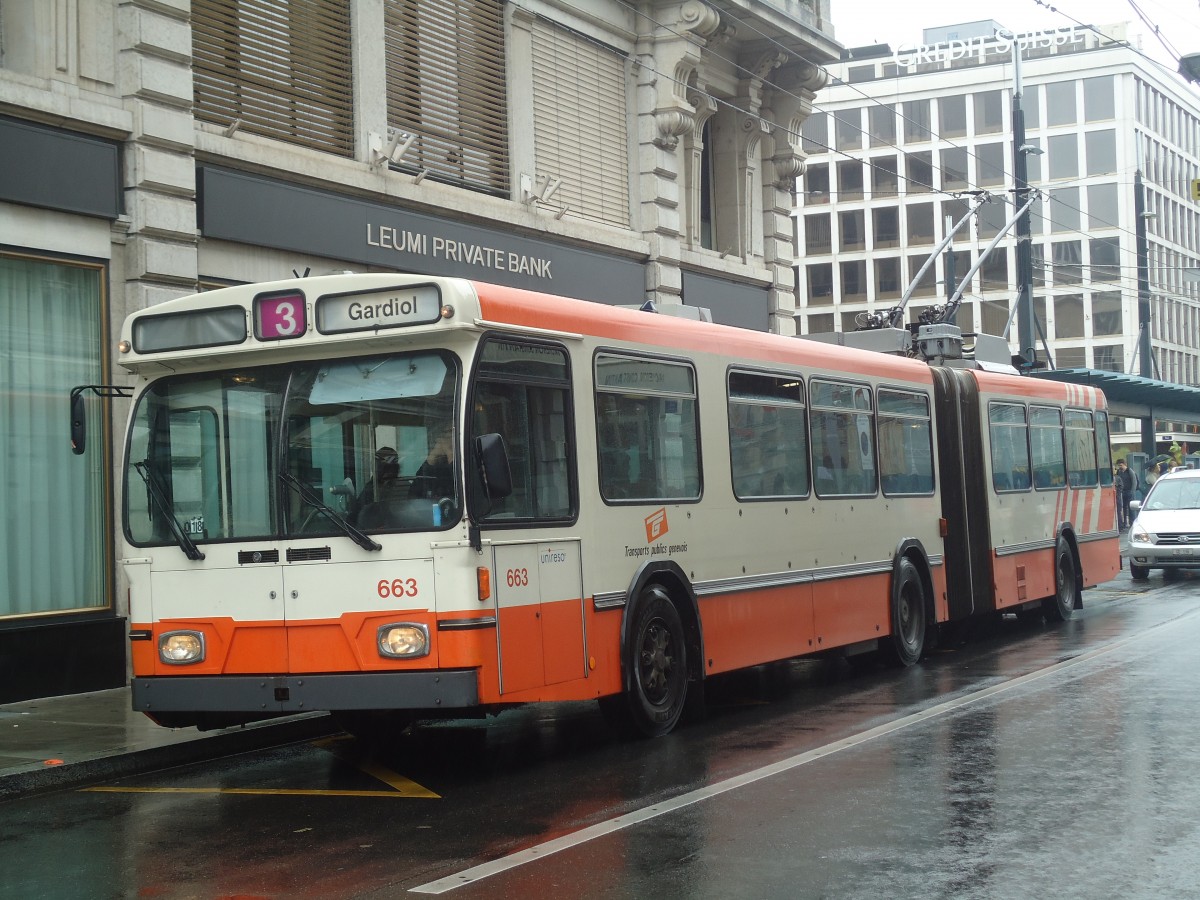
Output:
[{"xmin": 0, "ymin": 256, "xmax": 108, "ymax": 618}]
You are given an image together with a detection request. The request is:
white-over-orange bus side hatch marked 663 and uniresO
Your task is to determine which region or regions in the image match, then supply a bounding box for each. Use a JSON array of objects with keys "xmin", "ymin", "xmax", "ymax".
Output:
[{"xmin": 492, "ymin": 539, "xmax": 587, "ymax": 694}]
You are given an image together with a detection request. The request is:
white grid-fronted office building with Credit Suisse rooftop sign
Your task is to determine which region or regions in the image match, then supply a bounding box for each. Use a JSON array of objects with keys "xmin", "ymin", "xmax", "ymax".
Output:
[{"xmin": 797, "ymin": 20, "xmax": 1200, "ymax": 398}]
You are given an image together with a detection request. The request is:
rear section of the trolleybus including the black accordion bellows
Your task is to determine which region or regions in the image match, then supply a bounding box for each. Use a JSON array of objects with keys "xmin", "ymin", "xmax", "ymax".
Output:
[{"xmin": 934, "ymin": 367, "xmax": 1120, "ymax": 622}]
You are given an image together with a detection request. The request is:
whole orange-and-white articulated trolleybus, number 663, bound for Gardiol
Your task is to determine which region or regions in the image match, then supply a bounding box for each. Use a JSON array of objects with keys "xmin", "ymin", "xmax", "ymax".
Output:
[{"xmin": 88, "ymin": 274, "xmax": 1118, "ymax": 736}]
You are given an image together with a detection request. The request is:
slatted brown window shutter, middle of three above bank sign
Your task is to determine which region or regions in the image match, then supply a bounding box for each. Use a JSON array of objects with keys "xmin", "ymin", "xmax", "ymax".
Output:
[{"xmin": 384, "ymin": 0, "xmax": 509, "ymax": 197}]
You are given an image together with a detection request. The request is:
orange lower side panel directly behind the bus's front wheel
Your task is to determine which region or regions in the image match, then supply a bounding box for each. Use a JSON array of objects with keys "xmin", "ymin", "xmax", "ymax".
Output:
[{"xmin": 700, "ymin": 584, "xmax": 817, "ymax": 674}]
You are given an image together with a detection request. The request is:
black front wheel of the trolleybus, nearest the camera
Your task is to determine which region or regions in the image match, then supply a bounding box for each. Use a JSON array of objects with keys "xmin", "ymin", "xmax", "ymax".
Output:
[{"xmin": 607, "ymin": 586, "xmax": 688, "ymax": 738}]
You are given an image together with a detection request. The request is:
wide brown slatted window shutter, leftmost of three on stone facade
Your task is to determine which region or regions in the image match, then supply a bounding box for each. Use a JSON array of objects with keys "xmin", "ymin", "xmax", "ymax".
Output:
[{"xmin": 192, "ymin": 0, "xmax": 354, "ymax": 156}]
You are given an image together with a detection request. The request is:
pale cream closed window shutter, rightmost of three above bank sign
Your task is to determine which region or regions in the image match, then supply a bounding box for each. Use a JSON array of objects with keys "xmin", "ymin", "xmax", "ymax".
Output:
[{"xmin": 533, "ymin": 19, "xmax": 629, "ymax": 227}]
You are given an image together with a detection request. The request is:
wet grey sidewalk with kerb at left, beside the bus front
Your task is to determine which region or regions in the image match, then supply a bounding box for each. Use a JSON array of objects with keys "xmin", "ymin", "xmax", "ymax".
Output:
[{"xmin": 0, "ymin": 688, "xmax": 336, "ymax": 802}]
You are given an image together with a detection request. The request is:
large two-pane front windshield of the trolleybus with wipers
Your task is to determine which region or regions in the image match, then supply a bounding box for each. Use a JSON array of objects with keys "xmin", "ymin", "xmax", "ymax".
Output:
[{"xmin": 125, "ymin": 352, "xmax": 462, "ymax": 552}]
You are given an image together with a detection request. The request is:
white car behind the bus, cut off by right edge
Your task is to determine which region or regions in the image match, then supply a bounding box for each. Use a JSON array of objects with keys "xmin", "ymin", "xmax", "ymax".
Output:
[{"xmin": 1129, "ymin": 466, "xmax": 1200, "ymax": 581}]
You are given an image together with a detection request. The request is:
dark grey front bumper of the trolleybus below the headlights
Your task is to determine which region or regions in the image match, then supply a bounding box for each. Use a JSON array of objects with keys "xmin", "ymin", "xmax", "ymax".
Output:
[{"xmin": 132, "ymin": 668, "xmax": 479, "ymax": 715}]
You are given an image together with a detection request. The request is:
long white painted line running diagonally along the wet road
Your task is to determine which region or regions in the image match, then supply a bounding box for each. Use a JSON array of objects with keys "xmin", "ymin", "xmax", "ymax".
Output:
[{"xmin": 409, "ymin": 610, "xmax": 1200, "ymax": 894}]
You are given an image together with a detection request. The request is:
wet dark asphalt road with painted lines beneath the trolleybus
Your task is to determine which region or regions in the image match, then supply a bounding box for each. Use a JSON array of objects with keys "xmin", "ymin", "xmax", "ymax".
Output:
[{"xmin": 0, "ymin": 572, "xmax": 1200, "ymax": 900}]
